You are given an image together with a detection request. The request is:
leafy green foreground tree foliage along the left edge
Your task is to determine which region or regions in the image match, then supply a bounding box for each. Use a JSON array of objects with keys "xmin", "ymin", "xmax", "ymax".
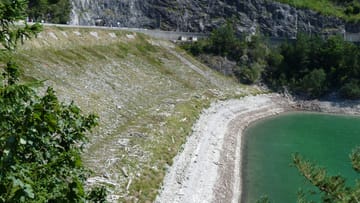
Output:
[{"xmin": 0, "ymin": 0, "xmax": 106, "ymax": 202}]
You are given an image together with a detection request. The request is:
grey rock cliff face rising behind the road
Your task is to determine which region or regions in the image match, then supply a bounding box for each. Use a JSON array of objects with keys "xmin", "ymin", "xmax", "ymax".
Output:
[{"xmin": 72, "ymin": 0, "xmax": 345, "ymax": 37}]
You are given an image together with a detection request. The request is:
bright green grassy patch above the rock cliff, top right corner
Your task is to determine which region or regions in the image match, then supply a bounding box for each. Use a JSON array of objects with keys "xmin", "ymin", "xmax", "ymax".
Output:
[{"xmin": 277, "ymin": 0, "xmax": 360, "ymax": 22}]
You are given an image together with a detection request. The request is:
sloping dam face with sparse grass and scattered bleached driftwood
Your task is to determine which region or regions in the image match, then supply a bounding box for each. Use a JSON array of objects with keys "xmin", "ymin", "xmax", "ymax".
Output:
[{"xmin": 11, "ymin": 27, "xmax": 252, "ymax": 202}]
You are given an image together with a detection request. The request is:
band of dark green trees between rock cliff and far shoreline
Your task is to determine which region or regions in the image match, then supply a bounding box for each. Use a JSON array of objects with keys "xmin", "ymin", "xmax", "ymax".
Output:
[{"xmin": 183, "ymin": 24, "xmax": 360, "ymax": 99}]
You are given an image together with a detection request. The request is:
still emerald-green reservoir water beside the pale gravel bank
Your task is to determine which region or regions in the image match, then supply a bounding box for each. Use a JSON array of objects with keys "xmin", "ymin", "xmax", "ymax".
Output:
[{"xmin": 242, "ymin": 113, "xmax": 360, "ymax": 203}]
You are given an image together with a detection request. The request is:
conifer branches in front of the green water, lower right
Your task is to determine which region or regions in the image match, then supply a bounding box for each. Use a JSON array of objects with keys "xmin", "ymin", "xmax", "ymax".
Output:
[{"xmin": 293, "ymin": 147, "xmax": 360, "ymax": 203}]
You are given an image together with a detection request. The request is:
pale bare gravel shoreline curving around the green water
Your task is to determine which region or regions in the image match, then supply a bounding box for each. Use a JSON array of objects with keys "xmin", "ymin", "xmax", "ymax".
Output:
[{"xmin": 155, "ymin": 93, "xmax": 360, "ymax": 203}]
